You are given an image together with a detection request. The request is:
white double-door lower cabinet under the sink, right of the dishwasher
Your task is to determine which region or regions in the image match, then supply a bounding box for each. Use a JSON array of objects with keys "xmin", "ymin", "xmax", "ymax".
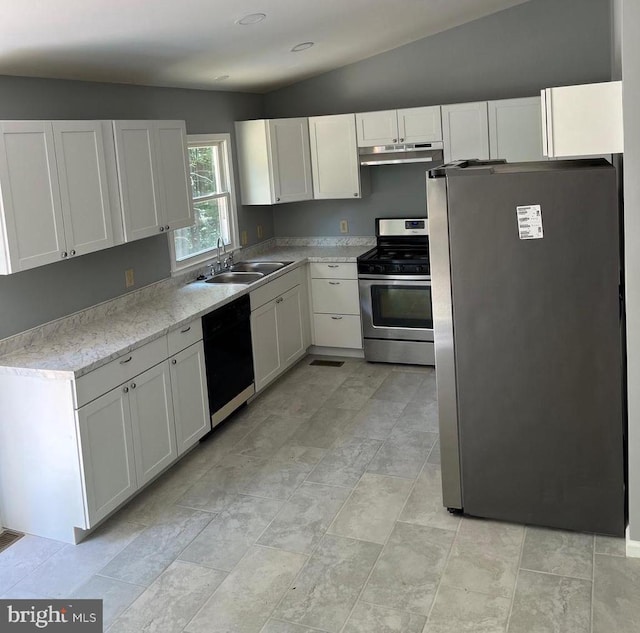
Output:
[{"xmin": 250, "ymin": 269, "xmax": 307, "ymax": 392}]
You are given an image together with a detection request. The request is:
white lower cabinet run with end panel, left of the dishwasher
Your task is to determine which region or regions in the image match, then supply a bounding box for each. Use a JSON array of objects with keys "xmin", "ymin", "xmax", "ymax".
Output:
[{"xmin": 0, "ymin": 319, "xmax": 211, "ymax": 543}]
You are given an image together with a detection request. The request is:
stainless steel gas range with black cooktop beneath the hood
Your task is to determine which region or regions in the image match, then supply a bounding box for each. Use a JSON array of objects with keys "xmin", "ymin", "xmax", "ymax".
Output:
[{"xmin": 358, "ymin": 218, "xmax": 435, "ymax": 365}]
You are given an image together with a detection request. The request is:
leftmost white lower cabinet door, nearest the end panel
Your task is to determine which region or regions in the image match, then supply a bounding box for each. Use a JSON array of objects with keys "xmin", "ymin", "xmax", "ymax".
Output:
[{"xmin": 78, "ymin": 387, "xmax": 138, "ymax": 527}]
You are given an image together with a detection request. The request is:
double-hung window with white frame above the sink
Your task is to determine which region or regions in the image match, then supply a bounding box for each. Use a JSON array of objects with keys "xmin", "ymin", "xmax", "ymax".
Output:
[{"xmin": 172, "ymin": 134, "xmax": 238, "ymax": 271}]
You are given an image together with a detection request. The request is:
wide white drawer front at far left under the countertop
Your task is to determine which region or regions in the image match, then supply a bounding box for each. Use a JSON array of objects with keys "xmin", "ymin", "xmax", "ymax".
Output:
[{"xmin": 76, "ymin": 336, "xmax": 168, "ymax": 408}]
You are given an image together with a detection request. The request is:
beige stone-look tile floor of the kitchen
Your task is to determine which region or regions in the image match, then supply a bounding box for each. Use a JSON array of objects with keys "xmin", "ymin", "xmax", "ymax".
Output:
[{"xmin": 0, "ymin": 358, "xmax": 640, "ymax": 633}]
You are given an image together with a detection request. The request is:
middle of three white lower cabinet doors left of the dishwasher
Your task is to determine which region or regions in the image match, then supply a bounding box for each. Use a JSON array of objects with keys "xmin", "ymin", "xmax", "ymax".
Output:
[{"xmin": 128, "ymin": 361, "xmax": 178, "ymax": 486}]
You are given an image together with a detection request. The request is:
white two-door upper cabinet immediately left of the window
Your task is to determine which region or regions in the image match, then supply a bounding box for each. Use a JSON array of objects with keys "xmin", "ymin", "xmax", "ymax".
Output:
[{"xmin": 113, "ymin": 121, "xmax": 193, "ymax": 242}]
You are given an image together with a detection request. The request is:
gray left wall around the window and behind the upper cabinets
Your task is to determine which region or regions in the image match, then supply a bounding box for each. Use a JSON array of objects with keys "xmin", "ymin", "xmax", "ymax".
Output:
[{"xmin": 0, "ymin": 77, "xmax": 264, "ymax": 338}]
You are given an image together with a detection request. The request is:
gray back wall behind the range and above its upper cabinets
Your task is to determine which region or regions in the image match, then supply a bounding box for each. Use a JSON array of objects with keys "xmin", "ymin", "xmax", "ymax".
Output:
[{"xmin": 265, "ymin": 0, "xmax": 612, "ymax": 237}]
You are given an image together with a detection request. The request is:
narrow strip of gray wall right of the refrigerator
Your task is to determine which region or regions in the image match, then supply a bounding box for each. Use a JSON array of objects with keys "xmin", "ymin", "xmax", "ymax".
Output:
[{"xmin": 622, "ymin": 0, "xmax": 640, "ymax": 544}]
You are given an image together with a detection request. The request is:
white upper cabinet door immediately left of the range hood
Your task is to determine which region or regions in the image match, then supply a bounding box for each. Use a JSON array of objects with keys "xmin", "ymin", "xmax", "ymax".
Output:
[{"xmin": 309, "ymin": 114, "xmax": 361, "ymax": 199}]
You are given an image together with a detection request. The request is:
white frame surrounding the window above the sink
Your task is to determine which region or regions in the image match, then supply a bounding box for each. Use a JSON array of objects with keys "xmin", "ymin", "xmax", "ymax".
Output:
[{"xmin": 169, "ymin": 133, "xmax": 240, "ymax": 274}]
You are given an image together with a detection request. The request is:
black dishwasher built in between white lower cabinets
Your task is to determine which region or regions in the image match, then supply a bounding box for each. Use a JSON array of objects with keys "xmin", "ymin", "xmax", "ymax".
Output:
[{"xmin": 202, "ymin": 295, "xmax": 255, "ymax": 427}]
